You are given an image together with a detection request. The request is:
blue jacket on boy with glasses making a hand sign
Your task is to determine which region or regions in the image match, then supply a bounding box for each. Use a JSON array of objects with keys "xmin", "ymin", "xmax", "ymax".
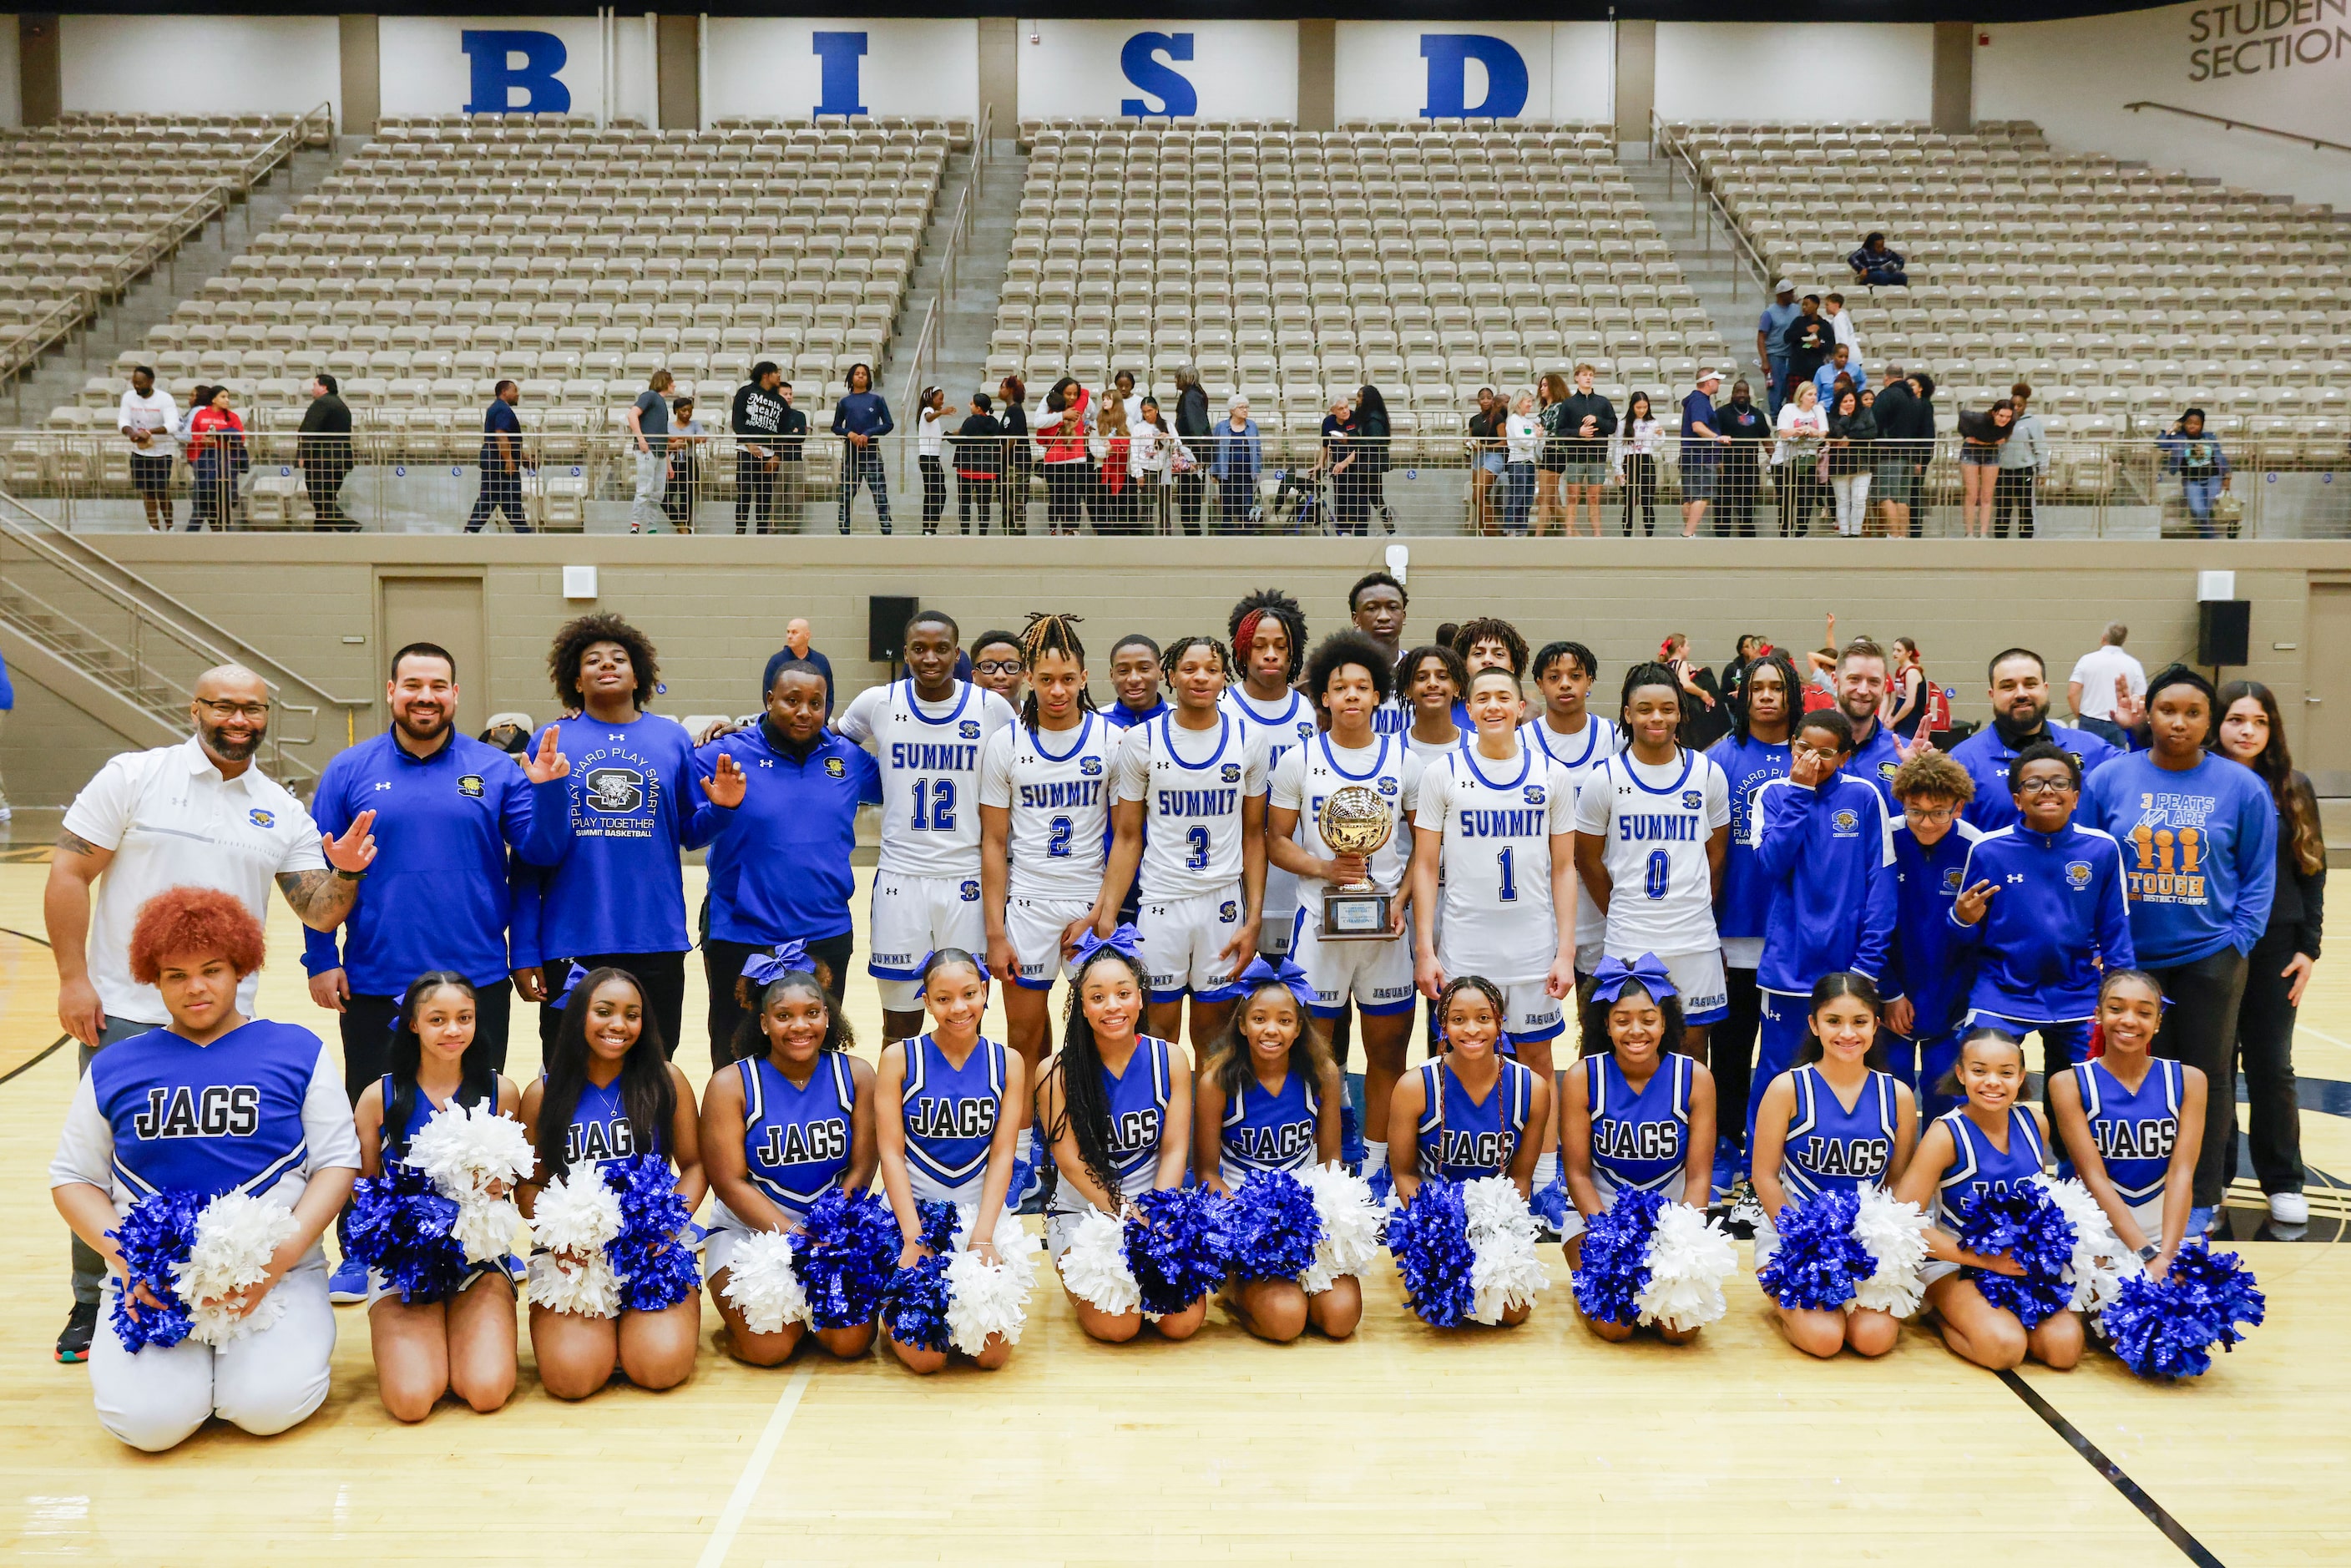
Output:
[{"xmin": 1947, "ymin": 822, "xmax": 2140, "ymax": 1023}]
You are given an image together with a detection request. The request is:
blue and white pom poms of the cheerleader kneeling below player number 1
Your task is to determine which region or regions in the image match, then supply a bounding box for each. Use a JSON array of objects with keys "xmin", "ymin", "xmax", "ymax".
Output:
[{"xmin": 1387, "ymin": 1176, "xmax": 1552, "ymax": 1328}]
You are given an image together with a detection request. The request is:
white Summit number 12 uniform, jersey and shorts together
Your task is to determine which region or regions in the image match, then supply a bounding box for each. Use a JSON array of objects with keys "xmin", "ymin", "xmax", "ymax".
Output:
[{"xmin": 832, "ymin": 677, "xmax": 1016, "ymax": 1014}]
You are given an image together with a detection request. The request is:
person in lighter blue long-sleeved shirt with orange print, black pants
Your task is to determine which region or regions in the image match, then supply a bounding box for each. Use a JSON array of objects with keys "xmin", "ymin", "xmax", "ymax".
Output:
[{"xmin": 2083, "ymin": 665, "xmax": 2278, "ymax": 1237}]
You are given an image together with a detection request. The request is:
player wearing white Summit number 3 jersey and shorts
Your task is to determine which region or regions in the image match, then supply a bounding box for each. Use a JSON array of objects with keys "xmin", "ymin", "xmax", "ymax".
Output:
[{"xmin": 1095, "ymin": 637, "xmax": 1265, "ymax": 1053}]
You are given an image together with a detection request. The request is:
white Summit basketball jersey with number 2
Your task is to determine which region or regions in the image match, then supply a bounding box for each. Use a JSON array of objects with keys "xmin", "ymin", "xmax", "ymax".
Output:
[{"xmin": 980, "ymin": 712, "xmax": 1119, "ymax": 900}]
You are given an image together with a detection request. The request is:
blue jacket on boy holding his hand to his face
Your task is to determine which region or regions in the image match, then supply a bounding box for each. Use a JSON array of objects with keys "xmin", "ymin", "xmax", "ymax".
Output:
[{"xmin": 1757, "ymin": 771, "xmax": 1899, "ymax": 1001}]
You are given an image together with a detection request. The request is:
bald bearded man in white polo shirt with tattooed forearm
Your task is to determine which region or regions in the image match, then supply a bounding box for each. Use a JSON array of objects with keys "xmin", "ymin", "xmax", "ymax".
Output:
[{"xmin": 40, "ymin": 665, "xmax": 377, "ymax": 1361}]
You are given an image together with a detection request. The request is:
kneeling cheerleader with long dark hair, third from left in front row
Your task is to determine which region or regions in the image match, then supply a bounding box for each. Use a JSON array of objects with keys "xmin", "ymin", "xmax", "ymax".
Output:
[{"xmin": 522, "ymin": 969, "xmax": 708, "ymax": 1399}]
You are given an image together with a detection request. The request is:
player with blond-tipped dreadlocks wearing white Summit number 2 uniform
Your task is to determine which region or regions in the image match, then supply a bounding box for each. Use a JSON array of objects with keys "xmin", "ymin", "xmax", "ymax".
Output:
[{"xmin": 980, "ymin": 614, "xmax": 1119, "ymax": 1204}]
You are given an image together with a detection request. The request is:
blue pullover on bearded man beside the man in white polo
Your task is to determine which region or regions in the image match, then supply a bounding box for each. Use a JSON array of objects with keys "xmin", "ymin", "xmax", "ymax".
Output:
[{"xmin": 303, "ymin": 731, "xmax": 567, "ymax": 997}]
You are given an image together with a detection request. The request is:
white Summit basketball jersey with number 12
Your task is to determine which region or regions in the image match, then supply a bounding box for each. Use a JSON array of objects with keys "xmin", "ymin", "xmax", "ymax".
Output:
[{"xmin": 835, "ymin": 680, "xmax": 1014, "ymax": 877}]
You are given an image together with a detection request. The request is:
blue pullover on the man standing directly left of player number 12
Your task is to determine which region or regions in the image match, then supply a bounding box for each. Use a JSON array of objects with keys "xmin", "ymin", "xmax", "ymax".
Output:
[{"xmin": 694, "ymin": 720, "xmax": 882, "ymax": 948}]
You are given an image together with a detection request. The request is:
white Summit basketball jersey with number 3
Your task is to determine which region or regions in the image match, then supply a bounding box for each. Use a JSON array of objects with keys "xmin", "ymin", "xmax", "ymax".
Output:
[{"xmin": 1119, "ymin": 710, "xmax": 1265, "ymax": 898}]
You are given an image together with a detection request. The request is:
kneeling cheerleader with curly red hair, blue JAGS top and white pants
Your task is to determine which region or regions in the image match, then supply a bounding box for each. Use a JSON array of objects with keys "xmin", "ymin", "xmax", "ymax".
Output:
[{"xmin": 49, "ymin": 886, "xmax": 360, "ymax": 1453}]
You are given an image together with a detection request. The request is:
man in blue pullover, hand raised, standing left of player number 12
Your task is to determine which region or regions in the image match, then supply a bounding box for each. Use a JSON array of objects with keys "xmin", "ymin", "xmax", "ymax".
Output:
[{"xmin": 694, "ymin": 658, "xmax": 882, "ymax": 1070}]
